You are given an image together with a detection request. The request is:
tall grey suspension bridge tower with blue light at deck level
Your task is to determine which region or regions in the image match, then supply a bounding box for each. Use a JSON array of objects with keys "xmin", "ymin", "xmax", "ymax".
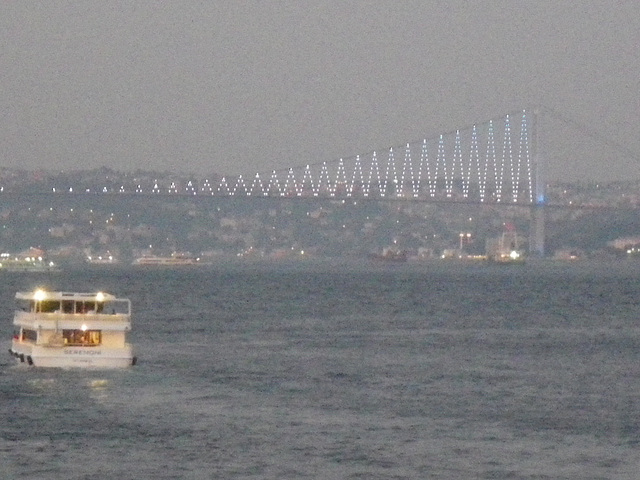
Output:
[{"xmin": 529, "ymin": 108, "xmax": 546, "ymax": 257}]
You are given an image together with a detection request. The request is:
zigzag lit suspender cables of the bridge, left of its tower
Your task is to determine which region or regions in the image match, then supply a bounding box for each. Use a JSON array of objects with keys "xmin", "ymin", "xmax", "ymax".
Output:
[{"xmin": 47, "ymin": 111, "xmax": 534, "ymax": 203}]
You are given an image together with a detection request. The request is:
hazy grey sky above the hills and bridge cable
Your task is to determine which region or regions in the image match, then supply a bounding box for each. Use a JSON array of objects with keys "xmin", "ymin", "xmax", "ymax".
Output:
[{"xmin": 0, "ymin": 0, "xmax": 640, "ymax": 179}]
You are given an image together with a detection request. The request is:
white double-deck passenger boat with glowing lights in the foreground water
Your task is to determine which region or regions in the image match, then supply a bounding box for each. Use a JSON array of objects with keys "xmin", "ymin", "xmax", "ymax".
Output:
[{"xmin": 9, "ymin": 290, "xmax": 136, "ymax": 368}]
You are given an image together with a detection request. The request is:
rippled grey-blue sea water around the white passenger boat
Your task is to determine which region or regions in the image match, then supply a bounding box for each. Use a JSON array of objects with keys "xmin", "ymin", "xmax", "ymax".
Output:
[{"xmin": 0, "ymin": 260, "xmax": 640, "ymax": 480}]
